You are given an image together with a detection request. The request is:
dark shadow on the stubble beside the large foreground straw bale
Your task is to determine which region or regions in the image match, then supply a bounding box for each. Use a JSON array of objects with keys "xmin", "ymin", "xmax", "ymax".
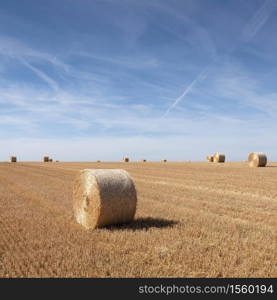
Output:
[{"xmin": 105, "ymin": 217, "xmax": 178, "ymax": 231}]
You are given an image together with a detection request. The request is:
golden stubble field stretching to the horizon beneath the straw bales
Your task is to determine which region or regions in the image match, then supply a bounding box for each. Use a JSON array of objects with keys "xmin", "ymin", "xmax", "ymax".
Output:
[{"xmin": 0, "ymin": 162, "xmax": 277, "ymax": 277}]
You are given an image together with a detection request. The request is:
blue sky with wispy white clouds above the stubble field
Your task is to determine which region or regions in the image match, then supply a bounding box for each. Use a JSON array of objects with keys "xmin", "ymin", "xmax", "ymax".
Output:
[{"xmin": 0, "ymin": 0, "xmax": 277, "ymax": 161}]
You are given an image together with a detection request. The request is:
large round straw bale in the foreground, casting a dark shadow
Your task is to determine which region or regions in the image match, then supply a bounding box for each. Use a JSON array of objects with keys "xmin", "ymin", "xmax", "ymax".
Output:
[{"xmin": 73, "ymin": 169, "xmax": 137, "ymax": 229}]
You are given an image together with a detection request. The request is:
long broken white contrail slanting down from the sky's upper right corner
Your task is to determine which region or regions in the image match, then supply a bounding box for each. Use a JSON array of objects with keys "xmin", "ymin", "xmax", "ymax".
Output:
[{"xmin": 161, "ymin": 0, "xmax": 277, "ymax": 119}]
